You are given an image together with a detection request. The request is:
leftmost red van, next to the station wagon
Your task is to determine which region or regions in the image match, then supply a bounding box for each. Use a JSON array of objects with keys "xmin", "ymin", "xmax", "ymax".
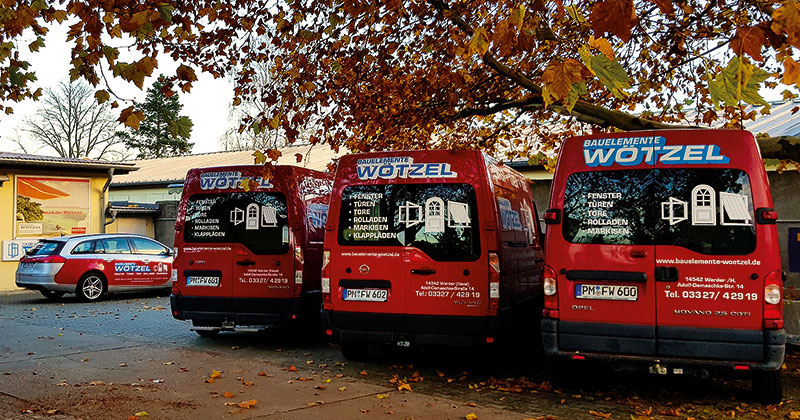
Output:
[{"xmin": 170, "ymin": 165, "xmax": 333, "ymax": 336}]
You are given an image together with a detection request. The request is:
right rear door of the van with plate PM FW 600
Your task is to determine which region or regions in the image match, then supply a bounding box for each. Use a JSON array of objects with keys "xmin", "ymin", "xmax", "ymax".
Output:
[{"xmin": 655, "ymin": 133, "xmax": 765, "ymax": 360}]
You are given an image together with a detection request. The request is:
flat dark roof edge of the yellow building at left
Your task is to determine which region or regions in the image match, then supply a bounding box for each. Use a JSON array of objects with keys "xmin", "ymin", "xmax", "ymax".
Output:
[{"xmin": 0, "ymin": 152, "xmax": 139, "ymax": 174}]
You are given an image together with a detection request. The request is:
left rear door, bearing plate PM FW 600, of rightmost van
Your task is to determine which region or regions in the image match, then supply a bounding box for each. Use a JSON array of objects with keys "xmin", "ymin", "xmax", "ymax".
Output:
[{"xmin": 548, "ymin": 158, "xmax": 656, "ymax": 355}]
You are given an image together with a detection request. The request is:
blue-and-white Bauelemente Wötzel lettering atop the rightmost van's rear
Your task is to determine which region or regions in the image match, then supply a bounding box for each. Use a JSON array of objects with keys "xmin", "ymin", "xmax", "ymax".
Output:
[{"xmin": 583, "ymin": 136, "xmax": 730, "ymax": 167}]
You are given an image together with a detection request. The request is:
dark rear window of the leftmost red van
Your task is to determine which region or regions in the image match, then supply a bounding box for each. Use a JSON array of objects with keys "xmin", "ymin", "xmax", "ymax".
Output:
[{"xmin": 183, "ymin": 192, "xmax": 289, "ymax": 255}]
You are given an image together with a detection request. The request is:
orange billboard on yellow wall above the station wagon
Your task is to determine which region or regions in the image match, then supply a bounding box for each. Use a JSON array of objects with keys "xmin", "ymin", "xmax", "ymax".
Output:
[{"xmin": 14, "ymin": 176, "xmax": 91, "ymax": 237}]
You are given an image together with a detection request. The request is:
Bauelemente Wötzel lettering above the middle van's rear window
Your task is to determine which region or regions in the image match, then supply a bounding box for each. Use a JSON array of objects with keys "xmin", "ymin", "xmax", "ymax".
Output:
[{"xmin": 356, "ymin": 156, "xmax": 458, "ymax": 179}]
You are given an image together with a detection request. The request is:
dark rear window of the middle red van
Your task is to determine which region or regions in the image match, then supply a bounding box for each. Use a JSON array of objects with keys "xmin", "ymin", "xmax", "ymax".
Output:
[{"xmin": 339, "ymin": 184, "xmax": 481, "ymax": 261}]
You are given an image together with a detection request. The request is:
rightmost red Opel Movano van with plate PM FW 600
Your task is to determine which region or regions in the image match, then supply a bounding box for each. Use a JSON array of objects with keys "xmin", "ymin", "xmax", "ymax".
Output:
[{"xmin": 542, "ymin": 130, "xmax": 786, "ymax": 402}]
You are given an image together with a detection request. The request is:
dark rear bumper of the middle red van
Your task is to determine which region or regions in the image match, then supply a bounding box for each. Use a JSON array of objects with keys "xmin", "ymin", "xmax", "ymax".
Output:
[{"xmin": 320, "ymin": 310, "xmax": 499, "ymax": 346}]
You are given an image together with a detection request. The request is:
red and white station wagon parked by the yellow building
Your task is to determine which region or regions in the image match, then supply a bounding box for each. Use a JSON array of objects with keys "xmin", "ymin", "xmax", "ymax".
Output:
[{"xmin": 16, "ymin": 233, "xmax": 172, "ymax": 301}]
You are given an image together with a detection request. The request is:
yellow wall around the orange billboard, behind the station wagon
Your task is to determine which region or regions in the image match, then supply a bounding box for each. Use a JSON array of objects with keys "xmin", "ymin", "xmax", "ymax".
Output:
[{"xmin": 0, "ymin": 169, "xmax": 113, "ymax": 290}]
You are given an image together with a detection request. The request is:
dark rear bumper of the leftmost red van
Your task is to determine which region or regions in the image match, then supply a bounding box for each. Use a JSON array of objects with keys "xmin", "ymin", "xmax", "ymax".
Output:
[{"xmin": 169, "ymin": 292, "xmax": 320, "ymax": 326}]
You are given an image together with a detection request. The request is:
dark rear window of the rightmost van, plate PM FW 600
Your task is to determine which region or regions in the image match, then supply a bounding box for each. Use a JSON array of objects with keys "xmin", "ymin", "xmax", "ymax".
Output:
[{"xmin": 563, "ymin": 168, "xmax": 756, "ymax": 255}]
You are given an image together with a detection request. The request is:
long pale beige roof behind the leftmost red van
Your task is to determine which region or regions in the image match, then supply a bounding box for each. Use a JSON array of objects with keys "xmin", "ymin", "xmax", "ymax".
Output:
[{"xmin": 111, "ymin": 145, "xmax": 344, "ymax": 188}]
